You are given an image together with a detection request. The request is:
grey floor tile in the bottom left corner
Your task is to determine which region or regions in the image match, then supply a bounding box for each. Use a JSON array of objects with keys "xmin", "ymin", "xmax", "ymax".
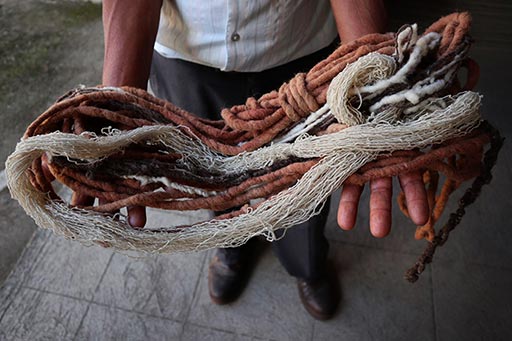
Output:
[{"xmin": 0, "ymin": 288, "xmax": 87, "ymax": 340}]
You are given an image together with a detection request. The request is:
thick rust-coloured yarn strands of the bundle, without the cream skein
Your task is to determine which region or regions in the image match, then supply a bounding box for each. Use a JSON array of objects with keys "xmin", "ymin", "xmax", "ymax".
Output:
[{"xmin": 17, "ymin": 13, "xmax": 504, "ymax": 279}]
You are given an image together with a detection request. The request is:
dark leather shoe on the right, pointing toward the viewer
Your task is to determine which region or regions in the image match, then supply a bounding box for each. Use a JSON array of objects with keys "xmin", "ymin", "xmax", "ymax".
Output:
[{"xmin": 297, "ymin": 274, "xmax": 340, "ymax": 320}]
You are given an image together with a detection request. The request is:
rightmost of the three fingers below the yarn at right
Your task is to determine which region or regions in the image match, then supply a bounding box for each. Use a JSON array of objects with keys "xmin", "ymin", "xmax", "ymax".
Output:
[{"xmin": 399, "ymin": 172, "xmax": 429, "ymax": 225}]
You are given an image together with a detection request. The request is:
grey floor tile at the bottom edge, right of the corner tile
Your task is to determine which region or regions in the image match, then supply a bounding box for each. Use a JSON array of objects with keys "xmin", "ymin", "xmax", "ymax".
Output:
[{"xmin": 76, "ymin": 303, "xmax": 182, "ymax": 341}]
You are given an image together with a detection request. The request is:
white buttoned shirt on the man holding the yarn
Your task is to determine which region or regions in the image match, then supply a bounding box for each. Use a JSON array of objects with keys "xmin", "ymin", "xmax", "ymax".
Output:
[{"xmin": 155, "ymin": 0, "xmax": 337, "ymax": 72}]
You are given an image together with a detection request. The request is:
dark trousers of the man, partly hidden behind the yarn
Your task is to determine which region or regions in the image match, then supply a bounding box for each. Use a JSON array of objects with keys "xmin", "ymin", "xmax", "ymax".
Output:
[{"xmin": 150, "ymin": 44, "xmax": 334, "ymax": 279}]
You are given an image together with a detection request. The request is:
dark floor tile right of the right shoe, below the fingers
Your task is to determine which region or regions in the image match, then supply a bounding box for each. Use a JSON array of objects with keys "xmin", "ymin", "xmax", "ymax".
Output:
[{"xmin": 313, "ymin": 243, "xmax": 435, "ymax": 340}]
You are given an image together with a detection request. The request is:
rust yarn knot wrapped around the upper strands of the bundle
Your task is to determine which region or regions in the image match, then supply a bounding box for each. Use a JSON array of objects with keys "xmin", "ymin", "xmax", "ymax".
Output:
[{"xmin": 279, "ymin": 73, "xmax": 320, "ymax": 122}]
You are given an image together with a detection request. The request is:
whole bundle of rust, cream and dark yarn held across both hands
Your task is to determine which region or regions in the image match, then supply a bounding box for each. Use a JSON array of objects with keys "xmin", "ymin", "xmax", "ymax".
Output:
[{"xmin": 6, "ymin": 13, "xmax": 501, "ymax": 281}]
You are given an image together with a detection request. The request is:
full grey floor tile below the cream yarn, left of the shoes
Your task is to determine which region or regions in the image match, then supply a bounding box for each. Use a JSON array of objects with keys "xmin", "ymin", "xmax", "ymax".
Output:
[{"xmin": 94, "ymin": 248, "xmax": 205, "ymax": 320}]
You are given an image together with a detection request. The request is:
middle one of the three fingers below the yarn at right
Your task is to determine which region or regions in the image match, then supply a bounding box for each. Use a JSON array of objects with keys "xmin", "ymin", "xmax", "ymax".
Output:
[{"xmin": 370, "ymin": 178, "xmax": 393, "ymax": 238}]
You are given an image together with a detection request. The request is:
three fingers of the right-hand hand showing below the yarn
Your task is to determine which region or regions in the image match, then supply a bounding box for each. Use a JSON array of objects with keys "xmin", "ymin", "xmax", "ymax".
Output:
[{"xmin": 338, "ymin": 172, "xmax": 429, "ymax": 238}]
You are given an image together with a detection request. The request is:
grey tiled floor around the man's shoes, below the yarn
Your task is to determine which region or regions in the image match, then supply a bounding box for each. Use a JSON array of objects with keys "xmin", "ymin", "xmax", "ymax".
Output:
[{"xmin": 0, "ymin": 197, "xmax": 512, "ymax": 340}]
